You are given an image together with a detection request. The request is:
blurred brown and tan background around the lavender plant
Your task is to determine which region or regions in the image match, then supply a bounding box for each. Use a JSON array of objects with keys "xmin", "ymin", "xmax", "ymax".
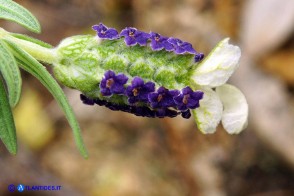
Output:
[{"xmin": 0, "ymin": 0, "xmax": 294, "ymax": 196}]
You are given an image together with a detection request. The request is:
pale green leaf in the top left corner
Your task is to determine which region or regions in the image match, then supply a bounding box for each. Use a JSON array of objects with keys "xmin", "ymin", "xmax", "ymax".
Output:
[{"xmin": 0, "ymin": 0, "xmax": 41, "ymax": 33}]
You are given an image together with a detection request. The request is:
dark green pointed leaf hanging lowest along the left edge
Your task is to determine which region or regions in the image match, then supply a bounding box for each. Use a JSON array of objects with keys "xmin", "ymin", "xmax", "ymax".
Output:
[{"xmin": 0, "ymin": 77, "xmax": 17, "ymax": 155}]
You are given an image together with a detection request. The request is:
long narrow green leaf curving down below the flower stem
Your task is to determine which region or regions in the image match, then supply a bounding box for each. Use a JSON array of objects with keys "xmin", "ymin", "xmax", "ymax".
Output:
[{"xmin": 6, "ymin": 40, "xmax": 88, "ymax": 158}]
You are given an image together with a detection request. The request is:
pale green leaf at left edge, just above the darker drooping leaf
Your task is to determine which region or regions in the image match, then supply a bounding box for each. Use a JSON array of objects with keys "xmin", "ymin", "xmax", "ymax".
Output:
[{"xmin": 0, "ymin": 40, "xmax": 21, "ymax": 107}]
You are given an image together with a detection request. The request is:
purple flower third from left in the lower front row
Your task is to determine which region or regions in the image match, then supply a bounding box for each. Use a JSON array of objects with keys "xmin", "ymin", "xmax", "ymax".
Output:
[{"xmin": 148, "ymin": 87, "xmax": 180, "ymax": 108}]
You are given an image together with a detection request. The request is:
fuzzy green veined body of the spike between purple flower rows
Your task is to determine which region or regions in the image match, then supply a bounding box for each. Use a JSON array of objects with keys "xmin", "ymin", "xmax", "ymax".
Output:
[{"xmin": 54, "ymin": 35, "xmax": 197, "ymax": 97}]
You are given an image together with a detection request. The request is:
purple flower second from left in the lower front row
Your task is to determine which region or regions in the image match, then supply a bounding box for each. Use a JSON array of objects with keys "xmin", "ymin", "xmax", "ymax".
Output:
[{"xmin": 126, "ymin": 77, "xmax": 155, "ymax": 104}]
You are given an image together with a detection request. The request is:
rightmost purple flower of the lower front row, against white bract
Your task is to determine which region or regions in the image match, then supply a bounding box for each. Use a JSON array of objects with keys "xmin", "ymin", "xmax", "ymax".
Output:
[{"xmin": 174, "ymin": 86, "xmax": 203, "ymax": 111}]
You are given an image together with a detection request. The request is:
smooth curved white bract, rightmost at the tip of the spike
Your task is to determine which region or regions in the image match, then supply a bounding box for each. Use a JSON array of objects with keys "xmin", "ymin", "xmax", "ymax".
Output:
[{"xmin": 216, "ymin": 84, "xmax": 248, "ymax": 134}]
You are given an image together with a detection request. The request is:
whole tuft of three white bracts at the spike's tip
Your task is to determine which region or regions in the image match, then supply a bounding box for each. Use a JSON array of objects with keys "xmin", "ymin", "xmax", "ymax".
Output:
[{"xmin": 192, "ymin": 38, "xmax": 248, "ymax": 134}]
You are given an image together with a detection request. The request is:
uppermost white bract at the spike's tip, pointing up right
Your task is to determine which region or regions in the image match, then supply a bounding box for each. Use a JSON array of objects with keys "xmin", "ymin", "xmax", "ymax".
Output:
[{"xmin": 191, "ymin": 38, "xmax": 241, "ymax": 87}]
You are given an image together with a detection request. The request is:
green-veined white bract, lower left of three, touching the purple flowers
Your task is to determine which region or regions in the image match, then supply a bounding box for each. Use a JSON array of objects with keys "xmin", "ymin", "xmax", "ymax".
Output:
[{"xmin": 192, "ymin": 88, "xmax": 223, "ymax": 134}]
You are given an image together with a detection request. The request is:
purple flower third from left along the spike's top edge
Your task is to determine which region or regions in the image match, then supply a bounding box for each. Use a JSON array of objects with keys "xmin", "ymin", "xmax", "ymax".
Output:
[{"xmin": 150, "ymin": 32, "xmax": 175, "ymax": 51}]
